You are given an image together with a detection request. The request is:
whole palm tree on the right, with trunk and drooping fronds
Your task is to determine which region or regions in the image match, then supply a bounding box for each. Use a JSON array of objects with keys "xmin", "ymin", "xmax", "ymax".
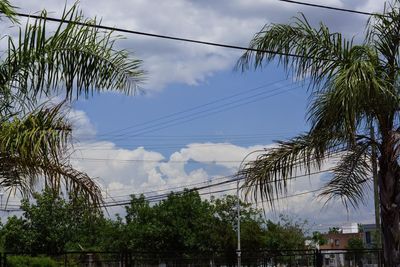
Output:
[{"xmin": 238, "ymin": 0, "xmax": 400, "ymax": 266}]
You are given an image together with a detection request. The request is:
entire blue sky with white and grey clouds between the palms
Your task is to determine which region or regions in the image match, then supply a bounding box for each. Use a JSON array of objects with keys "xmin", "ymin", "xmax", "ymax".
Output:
[{"xmin": 3, "ymin": 0, "xmax": 384, "ymax": 229}]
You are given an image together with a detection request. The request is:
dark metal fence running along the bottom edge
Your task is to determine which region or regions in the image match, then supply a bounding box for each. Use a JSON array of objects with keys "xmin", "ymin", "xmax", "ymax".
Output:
[{"xmin": 0, "ymin": 250, "xmax": 383, "ymax": 267}]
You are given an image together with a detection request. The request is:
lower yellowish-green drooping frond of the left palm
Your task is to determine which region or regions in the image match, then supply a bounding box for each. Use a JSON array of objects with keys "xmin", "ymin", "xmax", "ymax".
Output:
[{"xmin": 0, "ymin": 104, "xmax": 102, "ymax": 206}]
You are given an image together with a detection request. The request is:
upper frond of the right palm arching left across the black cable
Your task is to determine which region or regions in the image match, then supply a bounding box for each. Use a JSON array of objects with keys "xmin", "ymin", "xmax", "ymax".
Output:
[{"xmin": 237, "ymin": 15, "xmax": 352, "ymax": 90}]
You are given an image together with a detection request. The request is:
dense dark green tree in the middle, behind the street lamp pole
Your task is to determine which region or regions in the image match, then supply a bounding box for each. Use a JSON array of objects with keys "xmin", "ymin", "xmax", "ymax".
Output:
[{"xmin": 120, "ymin": 191, "xmax": 272, "ymax": 264}]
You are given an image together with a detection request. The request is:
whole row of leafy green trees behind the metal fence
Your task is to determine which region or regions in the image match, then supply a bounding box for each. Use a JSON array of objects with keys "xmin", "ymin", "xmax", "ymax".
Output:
[{"xmin": 0, "ymin": 191, "xmax": 312, "ymax": 258}]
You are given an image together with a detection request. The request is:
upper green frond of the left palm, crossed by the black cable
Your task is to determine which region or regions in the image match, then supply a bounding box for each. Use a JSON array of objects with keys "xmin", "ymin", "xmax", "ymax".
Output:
[{"xmin": 2, "ymin": 3, "xmax": 143, "ymax": 103}]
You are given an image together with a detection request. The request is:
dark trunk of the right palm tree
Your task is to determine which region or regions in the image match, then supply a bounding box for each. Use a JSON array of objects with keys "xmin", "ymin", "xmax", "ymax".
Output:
[{"xmin": 379, "ymin": 145, "xmax": 400, "ymax": 267}]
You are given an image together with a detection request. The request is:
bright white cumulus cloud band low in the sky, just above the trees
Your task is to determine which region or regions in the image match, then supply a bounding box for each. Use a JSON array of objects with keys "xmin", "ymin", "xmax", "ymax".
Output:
[{"xmin": 64, "ymin": 109, "xmax": 373, "ymax": 226}]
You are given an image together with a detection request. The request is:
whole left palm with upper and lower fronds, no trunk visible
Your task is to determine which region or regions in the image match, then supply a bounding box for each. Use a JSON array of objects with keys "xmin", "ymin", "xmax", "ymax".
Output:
[{"xmin": 0, "ymin": 0, "xmax": 143, "ymax": 207}]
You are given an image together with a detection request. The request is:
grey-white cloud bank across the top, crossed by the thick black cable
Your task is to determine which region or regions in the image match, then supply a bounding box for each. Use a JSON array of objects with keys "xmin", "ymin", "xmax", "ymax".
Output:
[{"xmin": 8, "ymin": 0, "xmax": 384, "ymax": 92}]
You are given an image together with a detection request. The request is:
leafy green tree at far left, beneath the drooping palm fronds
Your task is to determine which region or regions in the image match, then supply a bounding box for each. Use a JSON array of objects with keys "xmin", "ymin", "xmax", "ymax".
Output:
[{"xmin": 1, "ymin": 190, "xmax": 106, "ymax": 254}]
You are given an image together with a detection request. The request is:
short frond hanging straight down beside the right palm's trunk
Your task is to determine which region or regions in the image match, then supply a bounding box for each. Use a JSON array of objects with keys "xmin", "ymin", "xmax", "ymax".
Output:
[{"xmin": 319, "ymin": 143, "xmax": 372, "ymax": 208}]
